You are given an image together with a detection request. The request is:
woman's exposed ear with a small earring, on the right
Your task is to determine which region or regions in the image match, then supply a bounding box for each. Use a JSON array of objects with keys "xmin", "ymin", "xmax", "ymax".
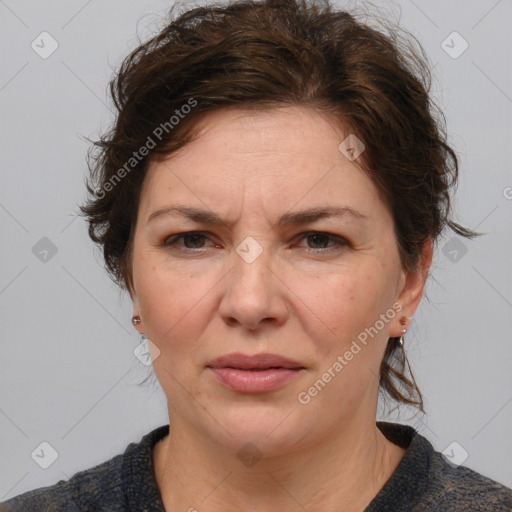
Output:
[{"xmin": 389, "ymin": 238, "xmax": 433, "ymax": 337}]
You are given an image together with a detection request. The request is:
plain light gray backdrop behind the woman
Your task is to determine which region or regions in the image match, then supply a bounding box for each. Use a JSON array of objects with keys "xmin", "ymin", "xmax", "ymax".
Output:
[{"xmin": 0, "ymin": 0, "xmax": 512, "ymax": 501}]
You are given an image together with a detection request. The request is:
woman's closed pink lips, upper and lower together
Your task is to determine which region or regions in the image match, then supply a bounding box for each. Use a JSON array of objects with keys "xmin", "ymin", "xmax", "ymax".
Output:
[{"xmin": 207, "ymin": 353, "xmax": 305, "ymax": 394}]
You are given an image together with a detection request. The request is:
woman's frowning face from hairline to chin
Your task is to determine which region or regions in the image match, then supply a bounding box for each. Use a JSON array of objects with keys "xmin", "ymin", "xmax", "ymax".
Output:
[{"xmin": 132, "ymin": 107, "xmax": 428, "ymax": 452}]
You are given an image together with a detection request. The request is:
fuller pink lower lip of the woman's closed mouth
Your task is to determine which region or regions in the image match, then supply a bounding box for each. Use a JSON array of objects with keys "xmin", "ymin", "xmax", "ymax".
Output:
[{"xmin": 210, "ymin": 368, "xmax": 301, "ymax": 393}]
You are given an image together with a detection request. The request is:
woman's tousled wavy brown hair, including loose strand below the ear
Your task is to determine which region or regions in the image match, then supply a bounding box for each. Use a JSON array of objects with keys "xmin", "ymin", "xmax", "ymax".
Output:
[{"xmin": 80, "ymin": 0, "xmax": 476, "ymax": 412}]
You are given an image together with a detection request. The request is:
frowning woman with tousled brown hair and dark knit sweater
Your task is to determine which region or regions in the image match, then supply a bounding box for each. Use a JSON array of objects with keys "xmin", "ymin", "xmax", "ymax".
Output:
[{"xmin": 1, "ymin": 0, "xmax": 512, "ymax": 512}]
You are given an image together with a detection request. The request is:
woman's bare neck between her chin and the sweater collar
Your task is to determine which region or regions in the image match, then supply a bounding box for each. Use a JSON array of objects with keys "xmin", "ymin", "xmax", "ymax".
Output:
[{"xmin": 153, "ymin": 419, "xmax": 405, "ymax": 512}]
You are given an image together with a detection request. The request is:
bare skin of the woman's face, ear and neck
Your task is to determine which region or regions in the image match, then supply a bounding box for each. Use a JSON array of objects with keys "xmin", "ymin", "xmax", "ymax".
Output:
[{"xmin": 131, "ymin": 106, "xmax": 432, "ymax": 512}]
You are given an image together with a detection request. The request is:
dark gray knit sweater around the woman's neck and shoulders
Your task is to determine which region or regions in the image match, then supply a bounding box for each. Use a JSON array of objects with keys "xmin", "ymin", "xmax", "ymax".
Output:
[{"xmin": 0, "ymin": 421, "xmax": 512, "ymax": 512}]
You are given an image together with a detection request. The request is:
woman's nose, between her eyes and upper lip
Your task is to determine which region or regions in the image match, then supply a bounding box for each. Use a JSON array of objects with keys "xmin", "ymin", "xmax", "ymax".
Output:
[{"xmin": 219, "ymin": 244, "xmax": 288, "ymax": 331}]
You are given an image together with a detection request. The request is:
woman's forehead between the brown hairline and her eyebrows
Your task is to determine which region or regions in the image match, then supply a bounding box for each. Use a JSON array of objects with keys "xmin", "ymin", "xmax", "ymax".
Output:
[{"xmin": 138, "ymin": 106, "xmax": 386, "ymax": 220}]
